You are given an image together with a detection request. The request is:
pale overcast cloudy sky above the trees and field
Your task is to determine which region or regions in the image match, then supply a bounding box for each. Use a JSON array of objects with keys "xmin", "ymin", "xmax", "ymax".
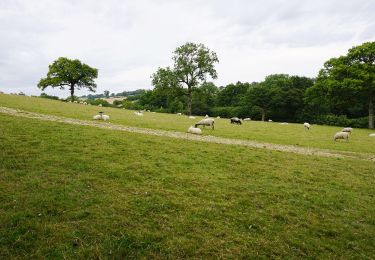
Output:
[{"xmin": 0, "ymin": 0, "xmax": 375, "ymax": 97}]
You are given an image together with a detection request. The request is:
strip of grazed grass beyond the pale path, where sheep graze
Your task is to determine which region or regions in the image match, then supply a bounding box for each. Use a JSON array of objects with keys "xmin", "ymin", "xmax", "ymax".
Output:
[{"xmin": 0, "ymin": 94, "xmax": 375, "ymax": 154}]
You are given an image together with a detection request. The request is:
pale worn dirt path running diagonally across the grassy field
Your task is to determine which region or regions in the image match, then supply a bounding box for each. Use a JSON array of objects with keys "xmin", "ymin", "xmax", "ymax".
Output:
[{"xmin": 0, "ymin": 107, "xmax": 375, "ymax": 161}]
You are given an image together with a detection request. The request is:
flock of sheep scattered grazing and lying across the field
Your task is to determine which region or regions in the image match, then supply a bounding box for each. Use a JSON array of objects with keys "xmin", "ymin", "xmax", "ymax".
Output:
[{"xmin": 93, "ymin": 110, "xmax": 364, "ymax": 142}]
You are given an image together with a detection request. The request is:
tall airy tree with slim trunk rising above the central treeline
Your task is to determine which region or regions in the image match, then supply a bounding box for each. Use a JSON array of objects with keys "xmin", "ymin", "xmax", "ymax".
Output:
[{"xmin": 152, "ymin": 42, "xmax": 219, "ymax": 115}]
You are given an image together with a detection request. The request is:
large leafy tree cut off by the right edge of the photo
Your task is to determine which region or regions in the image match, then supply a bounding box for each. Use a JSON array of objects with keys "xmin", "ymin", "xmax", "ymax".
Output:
[{"xmin": 309, "ymin": 42, "xmax": 375, "ymax": 128}]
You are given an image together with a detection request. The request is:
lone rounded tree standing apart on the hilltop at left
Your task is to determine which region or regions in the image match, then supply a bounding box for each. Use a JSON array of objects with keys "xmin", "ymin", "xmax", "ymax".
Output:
[{"xmin": 38, "ymin": 57, "xmax": 98, "ymax": 100}]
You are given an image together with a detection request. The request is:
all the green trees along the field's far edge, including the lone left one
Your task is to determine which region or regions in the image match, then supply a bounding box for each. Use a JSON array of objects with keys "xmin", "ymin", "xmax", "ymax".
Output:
[{"xmin": 38, "ymin": 42, "xmax": 375, "ymax": 128}]
